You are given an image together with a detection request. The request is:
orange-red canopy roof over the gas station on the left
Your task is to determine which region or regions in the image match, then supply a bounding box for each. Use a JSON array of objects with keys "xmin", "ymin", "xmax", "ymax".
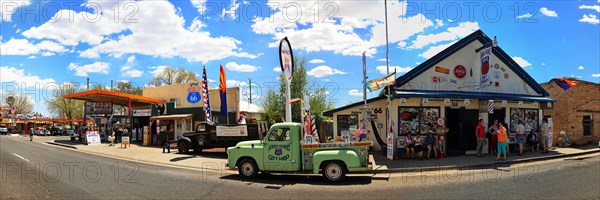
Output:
[{"xmin": 64, "ymin": 90, "xmax": 165, "ymax": 107}]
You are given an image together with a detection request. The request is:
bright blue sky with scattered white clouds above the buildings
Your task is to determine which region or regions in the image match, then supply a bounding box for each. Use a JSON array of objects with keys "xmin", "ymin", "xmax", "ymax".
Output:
[{"xmin": 0, "ymin": 0, "xmax": 600, "ymax": 114}]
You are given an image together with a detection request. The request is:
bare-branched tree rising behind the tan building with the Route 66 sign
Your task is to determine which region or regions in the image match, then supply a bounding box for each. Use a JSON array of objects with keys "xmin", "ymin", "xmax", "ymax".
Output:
[{"xmin": 148, "ymin": 66, "xmax": 200, "ymax": 86}]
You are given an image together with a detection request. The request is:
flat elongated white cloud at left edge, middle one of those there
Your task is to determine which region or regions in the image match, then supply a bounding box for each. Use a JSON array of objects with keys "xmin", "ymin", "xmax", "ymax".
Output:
[{"xmin": 0, "ymin": 36, "xmax": 68, "ymax": 56}]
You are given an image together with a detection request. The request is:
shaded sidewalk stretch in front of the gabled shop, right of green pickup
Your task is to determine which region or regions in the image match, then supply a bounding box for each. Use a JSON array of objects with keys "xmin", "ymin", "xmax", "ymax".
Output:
[{"xmin": 373, "ymin": 145, "xmax": 600, "ymax": 173}]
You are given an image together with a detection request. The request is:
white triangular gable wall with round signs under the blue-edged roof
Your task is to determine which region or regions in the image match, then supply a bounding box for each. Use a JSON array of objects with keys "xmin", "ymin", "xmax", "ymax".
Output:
[{"xmin": 400, "ymin": 40, "xmax": 542, "ymax": 96}]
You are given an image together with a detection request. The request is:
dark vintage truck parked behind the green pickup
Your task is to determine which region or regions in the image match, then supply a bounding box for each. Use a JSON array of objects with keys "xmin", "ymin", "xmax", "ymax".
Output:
[{"xmin": 177, "ymin": 122, "xmax": 267, "ymax": 153}]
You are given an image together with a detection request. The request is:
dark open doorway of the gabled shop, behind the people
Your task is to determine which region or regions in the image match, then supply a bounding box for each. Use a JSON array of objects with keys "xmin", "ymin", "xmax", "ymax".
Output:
[{"xmin": 446, "ymin": 108, "xmax": 479, "ymax": 156}]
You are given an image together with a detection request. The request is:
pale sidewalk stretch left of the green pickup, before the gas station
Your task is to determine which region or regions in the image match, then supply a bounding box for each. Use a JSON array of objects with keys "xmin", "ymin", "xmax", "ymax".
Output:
[{"xmin": 34, "ymin": 137, "xmax": 233, "ymax": 173}]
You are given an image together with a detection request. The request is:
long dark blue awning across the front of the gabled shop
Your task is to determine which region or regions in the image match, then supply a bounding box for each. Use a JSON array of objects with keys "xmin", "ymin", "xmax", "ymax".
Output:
[{"xmin": 395, "ymin": 90, "xmax": 556, "ymax": 103}]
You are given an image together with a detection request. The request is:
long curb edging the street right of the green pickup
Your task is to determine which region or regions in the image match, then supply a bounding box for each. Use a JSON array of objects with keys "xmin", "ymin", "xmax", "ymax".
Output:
[{"xmin": 354, "ymin": 149, "xmax": 600, "ymax": 174}]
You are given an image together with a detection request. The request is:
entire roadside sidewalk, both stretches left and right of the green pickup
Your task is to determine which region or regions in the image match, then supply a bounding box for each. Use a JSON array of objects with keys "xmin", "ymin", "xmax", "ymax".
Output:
[{"xmin": 27, "ymin": 136, "xmax": 600, "ymax": 173}]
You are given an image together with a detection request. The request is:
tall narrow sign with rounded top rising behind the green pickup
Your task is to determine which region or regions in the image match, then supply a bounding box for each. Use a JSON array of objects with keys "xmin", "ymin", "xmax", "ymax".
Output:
[{"xmin": 279, "ymin": 37, "xmax": 294, "ymax": 122}]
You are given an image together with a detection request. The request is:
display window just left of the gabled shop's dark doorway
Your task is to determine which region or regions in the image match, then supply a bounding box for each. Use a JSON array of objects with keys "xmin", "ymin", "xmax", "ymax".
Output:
[{"xmin": 398, "ymin": 107, "xmax": 440, "ymax": 135}]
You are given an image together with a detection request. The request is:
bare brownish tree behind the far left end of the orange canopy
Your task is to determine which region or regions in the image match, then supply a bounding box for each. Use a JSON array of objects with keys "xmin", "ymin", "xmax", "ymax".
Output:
[{"xmin": 46, "ymin": 82, "xmax": 84, "ymax": 119}]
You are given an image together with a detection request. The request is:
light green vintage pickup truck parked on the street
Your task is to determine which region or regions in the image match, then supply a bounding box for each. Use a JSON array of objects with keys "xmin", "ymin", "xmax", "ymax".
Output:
[{"xmin": 227, "ymin": 123, "xmax": 372, "ymax": 182}]
